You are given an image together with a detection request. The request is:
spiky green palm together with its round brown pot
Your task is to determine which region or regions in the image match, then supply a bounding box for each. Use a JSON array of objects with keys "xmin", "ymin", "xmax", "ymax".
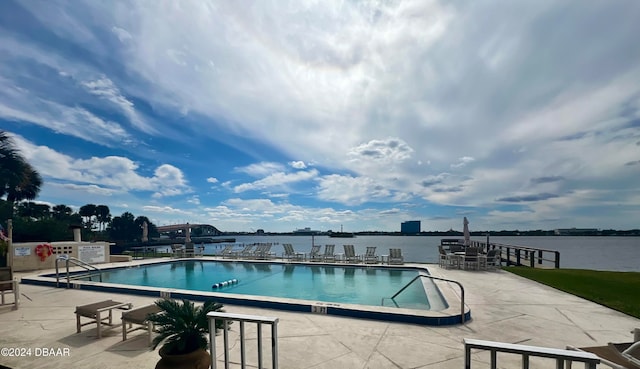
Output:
[{"xmin": 149, "ymin": 299, "xmax": 224, "ymax": 369}]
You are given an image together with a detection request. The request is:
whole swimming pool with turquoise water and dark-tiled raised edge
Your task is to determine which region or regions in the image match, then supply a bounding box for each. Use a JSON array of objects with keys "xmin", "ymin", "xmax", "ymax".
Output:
[{"xmin": 22, "ymin": 258, "xmax": 470, "ymax": 325}]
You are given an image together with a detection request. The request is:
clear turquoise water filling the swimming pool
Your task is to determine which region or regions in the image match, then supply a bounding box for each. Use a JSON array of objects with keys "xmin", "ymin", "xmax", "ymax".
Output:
[{"xmin": 95, "ymin": 260, "xmax": 430, "ymax": 310}]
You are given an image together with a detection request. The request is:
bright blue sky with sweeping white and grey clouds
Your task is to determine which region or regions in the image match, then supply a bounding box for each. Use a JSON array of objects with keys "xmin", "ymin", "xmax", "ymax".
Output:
[{"xmin": 0, "ymin": 0, "xmax": 640, "ymax": 232}]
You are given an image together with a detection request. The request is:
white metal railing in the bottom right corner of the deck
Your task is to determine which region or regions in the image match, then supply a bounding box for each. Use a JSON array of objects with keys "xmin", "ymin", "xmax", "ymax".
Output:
[{"xmin": 463, "ymin": 338, "xmax": 600, "ymax": 369}]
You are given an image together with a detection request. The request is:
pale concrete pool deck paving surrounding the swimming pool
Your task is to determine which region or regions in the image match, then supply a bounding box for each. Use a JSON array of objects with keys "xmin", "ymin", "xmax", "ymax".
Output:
[{"xmin": 0, "ymin": 258, "xmax": 640, "ymax": 369}]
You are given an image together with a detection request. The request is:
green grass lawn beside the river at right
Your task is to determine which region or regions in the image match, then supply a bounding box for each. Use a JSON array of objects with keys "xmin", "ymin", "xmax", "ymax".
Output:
[{"xmin": 503, "ymin": 267, "xmax": 640, "ymax": 318}]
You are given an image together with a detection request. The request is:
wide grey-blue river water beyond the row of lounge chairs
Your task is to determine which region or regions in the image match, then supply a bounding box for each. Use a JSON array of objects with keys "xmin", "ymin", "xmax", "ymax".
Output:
[{"xmin": 196, "ymin": 235, "xmax": 640, "ymax": 272}]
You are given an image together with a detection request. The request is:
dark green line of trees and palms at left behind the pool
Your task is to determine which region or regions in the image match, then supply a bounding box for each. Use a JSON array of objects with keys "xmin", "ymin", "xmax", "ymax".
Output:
[{"xmin": 0, "ymin": 130, "xmax": 159, "ymax": 243}]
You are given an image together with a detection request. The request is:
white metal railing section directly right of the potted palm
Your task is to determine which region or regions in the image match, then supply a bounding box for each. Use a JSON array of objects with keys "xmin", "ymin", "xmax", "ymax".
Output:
[{"xmin": 207, "ymin": 311, "xmax": 278, "ymax": 369}]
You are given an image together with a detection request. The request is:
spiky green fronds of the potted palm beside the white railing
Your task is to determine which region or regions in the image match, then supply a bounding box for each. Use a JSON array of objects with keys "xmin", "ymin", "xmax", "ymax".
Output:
[{"xmin": 149, "ymin": 300, "xmax": 223, "ymax": 355}]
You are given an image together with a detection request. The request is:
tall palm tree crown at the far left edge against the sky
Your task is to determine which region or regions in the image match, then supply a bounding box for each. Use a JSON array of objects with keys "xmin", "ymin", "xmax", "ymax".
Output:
[{"xmin": 0, "ymin": 131, "xmax": 42, "ymax": 213}]
